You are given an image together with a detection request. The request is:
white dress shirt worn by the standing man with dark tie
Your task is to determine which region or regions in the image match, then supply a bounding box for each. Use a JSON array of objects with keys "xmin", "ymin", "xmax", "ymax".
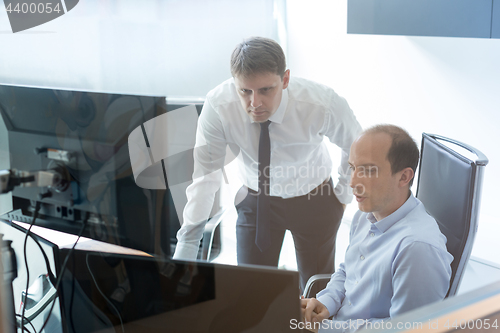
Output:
[{"xmin": 174, "ymin": 77, "xmax": 361, "ymax": 259}]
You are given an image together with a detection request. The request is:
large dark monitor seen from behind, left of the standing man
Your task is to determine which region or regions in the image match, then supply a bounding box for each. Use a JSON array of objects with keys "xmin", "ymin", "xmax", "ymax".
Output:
[{"xmin": 0, "ymin": 85, "xmax": 195, "ymax": 256}]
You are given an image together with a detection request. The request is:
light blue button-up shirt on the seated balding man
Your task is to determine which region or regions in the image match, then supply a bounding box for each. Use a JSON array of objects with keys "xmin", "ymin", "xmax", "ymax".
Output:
[{"xmin": 317, "ymin": 195, "xmax": 453, "ymax": 332}]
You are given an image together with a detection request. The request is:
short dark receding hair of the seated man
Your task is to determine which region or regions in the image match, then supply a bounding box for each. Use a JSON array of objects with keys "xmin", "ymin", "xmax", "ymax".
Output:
[{"xmin": 365, "ymin": 124, "xmax": 420, "ymax": 187}]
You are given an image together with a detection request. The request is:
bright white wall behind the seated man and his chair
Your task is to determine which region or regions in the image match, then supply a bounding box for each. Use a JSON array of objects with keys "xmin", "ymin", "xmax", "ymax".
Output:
[{"xmin": 287, "ymin": 0, "xmax": 500, "ymax": 262}]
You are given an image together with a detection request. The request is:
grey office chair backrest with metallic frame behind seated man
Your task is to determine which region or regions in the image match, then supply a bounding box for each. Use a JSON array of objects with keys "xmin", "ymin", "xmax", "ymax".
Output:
[{"xmin": 417, "ymin": 133, "xmax": 488, "ymax": 297}]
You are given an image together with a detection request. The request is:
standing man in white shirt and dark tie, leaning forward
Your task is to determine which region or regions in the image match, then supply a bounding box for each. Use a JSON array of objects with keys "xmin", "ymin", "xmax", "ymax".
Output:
[{"xmin": 174, "ymin": 37, "xmax": 361, "ymax": 288}]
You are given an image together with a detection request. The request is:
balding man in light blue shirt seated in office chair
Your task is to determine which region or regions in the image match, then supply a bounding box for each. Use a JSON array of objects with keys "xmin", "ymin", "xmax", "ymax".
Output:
[{"xmin": 301, "ymin": 125, "xmax": 453, "ymax": 332}]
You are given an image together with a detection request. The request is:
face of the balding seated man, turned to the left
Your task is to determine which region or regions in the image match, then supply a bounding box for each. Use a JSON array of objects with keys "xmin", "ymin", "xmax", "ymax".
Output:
[{"xmin": 349, "ymin": 133, "xmax": 404, "ymax": 221}]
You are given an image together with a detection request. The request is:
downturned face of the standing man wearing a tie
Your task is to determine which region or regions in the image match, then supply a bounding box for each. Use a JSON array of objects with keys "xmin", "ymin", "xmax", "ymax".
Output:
[{"xmin": 234, "ymin": 70, "xmax": 290, "ymax": 123}]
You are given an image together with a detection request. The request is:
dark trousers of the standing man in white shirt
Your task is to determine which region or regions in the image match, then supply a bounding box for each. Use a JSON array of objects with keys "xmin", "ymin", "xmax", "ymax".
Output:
[{"xmin": 236, "ymin": 180, "xmax": 344, "ymax": 290}]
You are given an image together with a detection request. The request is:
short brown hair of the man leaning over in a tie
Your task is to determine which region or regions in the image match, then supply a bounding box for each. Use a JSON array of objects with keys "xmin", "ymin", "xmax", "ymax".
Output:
[{"xmin": 231, "ymin": 37, "xmax": 286, "ymax": 79}]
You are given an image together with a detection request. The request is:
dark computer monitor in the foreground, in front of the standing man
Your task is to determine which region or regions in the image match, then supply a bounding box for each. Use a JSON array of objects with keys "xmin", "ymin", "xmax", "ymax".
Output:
[{"xmin": 63, "ymin": 251, "xmax": 300, "ymax": 333}]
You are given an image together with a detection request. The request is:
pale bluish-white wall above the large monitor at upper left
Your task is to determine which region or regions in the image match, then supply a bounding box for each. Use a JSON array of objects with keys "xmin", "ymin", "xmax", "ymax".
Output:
[{"xmin": 0, "ymin": 0, "xmax": 284, "ymax": 97}]
